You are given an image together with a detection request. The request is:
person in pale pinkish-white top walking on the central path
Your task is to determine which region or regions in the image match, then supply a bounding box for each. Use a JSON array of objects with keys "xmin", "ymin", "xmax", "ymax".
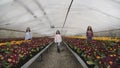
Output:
[{"xmin": 54, "ymin": 30, "xmax": 62, "ymax": 53}]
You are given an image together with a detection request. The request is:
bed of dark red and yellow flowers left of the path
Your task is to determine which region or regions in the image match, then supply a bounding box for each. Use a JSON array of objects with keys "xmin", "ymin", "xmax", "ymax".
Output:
[{"xmin": 0, "ymin": 38, "xmax": 52, "ymax": 68}]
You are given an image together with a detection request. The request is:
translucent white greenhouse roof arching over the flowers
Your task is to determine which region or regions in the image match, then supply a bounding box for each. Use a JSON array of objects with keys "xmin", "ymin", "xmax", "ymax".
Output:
[{"xmin": 0, "ymin": 0, "xmax": 120, "ymax": 36}]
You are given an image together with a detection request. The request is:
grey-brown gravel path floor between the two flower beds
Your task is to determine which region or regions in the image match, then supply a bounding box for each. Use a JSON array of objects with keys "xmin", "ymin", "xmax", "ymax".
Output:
[{"xmin": 29, "ymin": 44, "xmax": 83, "ymax": 68}]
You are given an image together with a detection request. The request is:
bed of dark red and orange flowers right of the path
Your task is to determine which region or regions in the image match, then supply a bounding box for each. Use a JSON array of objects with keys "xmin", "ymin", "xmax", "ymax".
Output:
[{"xmin": 65, "ymin": 38, "xmax": 120, "ymax": 68}]
